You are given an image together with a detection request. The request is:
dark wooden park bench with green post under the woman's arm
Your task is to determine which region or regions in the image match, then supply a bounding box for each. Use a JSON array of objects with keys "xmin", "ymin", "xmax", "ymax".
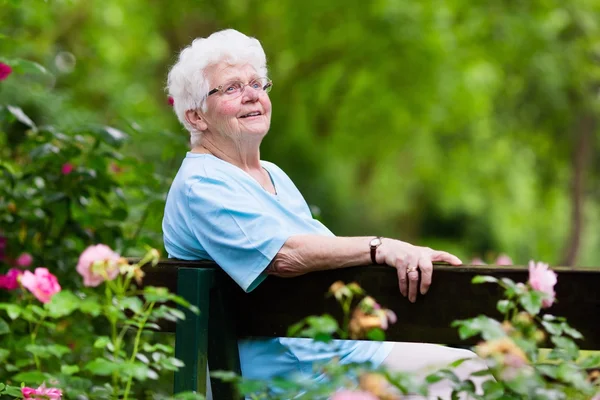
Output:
[{"xmin": 144, "ymin": 260, "xmax": 600, "ymax": 400}]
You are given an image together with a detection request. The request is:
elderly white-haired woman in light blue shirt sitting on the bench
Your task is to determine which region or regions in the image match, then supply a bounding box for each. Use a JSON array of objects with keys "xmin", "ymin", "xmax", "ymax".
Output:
[{"xmin": 163, "ymin": 30, "xmax": 488, "ymax": 395}]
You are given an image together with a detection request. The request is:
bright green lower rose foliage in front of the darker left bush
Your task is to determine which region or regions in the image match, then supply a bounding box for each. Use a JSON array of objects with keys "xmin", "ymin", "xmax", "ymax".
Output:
[{"xmin": 0, "ymin": 250, "xmax": 200, "ymax": 400}]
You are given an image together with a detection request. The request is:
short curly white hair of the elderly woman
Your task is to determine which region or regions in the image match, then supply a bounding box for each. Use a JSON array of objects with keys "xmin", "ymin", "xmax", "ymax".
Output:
[{"xmin": 167, "ymin": 29, "xmax": 267, "ymax": 147}]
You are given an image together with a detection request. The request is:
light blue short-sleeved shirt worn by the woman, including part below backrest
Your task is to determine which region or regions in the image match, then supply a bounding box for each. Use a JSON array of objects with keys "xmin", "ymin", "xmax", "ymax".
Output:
[{"xmin": 163, "ymin": 153, "xmax": 393, "ymax": 379}]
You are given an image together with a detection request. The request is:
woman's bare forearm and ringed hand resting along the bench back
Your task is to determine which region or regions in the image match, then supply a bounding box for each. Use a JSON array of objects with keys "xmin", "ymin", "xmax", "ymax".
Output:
[{"xmin": 267, "ymin": 235, "xmax": 462, "ymax": 302}]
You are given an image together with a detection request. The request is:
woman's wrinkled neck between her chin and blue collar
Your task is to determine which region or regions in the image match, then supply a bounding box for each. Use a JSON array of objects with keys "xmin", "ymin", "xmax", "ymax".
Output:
[{"xmin": 192, "ymin": 132, "xmax": 262, "ymax": 172}]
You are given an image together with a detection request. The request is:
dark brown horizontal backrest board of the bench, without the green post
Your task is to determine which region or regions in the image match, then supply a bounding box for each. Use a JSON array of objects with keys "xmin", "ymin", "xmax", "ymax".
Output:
[{"xmin": 146, "ymin": 261, "xmax": 600, "ymax": 349}]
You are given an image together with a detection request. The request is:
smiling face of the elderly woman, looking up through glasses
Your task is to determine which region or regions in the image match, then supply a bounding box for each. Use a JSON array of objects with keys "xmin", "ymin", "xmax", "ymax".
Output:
[{"xmin": 204, "ymin": 63, "xmax": 271, "ymax": 138}]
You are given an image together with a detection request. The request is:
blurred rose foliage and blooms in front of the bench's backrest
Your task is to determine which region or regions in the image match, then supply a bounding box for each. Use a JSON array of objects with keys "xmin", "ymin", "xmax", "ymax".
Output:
[{"xmin": 212, "ymin": 263, "xmax": 600, "ymax": 400}]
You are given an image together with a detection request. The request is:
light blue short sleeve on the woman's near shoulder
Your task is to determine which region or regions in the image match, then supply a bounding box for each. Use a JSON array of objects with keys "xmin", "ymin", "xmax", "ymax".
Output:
[{"xmin": 187, "ymin": 178, "xmax": 290, "ymax": 292}]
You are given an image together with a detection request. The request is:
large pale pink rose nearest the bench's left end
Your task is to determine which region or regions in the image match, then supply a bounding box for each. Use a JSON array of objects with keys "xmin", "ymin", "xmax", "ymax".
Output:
[{"xmin": 77, "ymin": 244, "xmax": 121, "ymax": 286}]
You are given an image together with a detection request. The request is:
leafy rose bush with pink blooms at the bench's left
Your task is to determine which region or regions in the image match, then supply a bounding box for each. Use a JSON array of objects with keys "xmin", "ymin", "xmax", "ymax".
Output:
[{"xmin": 0, "ymin": 59, "xmax": 202, "ymax": 399}]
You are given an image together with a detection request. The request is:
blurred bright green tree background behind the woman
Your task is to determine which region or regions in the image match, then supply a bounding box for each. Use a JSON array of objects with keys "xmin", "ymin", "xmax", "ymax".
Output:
[{"xmin": 0, "ymin": 0, "xmax": 600, "ymax": 266}]
